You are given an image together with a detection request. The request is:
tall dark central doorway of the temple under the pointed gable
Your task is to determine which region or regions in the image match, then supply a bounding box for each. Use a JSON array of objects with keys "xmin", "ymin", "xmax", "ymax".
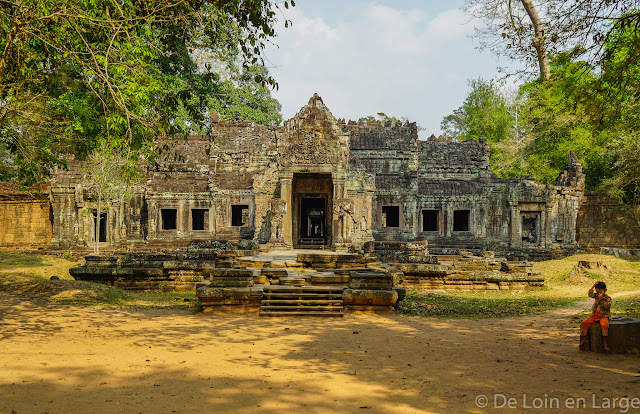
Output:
[{"xmin": 292, "ymin": 173, "xmax": 333, "ymax": 248}]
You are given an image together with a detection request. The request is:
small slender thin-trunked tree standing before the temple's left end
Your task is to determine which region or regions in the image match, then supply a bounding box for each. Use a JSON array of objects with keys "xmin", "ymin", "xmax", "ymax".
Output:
[{"xmin": 83, "ymin": 142, "xmax": 135, "ymax": 254}]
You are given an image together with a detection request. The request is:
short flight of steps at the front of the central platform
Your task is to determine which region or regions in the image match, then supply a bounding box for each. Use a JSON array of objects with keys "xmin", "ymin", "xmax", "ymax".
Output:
[{"xmin": 260, "ymin": 285, "xmax": 345, "ymax": 317}]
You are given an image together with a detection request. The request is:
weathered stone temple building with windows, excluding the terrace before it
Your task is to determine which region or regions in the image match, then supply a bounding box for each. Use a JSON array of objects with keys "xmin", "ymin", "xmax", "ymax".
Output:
[{"xmin": 50, "ymin": 95, "xmax": 584, "ymax": 259}]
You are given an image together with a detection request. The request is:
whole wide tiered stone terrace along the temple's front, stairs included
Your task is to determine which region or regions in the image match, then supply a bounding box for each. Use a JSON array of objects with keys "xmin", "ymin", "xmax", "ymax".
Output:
[{"xmin": 70, "ymin": 242, "xmax": 544, "ymax": 316}]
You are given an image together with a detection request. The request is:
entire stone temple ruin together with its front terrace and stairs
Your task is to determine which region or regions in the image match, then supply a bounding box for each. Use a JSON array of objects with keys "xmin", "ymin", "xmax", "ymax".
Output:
[{"xmin": 50, "ymin": 95, "xmax": 584, "ymax": 314}]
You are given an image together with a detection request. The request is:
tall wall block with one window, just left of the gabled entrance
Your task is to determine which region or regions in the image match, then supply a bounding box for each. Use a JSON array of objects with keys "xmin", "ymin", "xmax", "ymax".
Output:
[{"xmin": 209, "ymin": 122, "xmax": 282, "ymax": 243}]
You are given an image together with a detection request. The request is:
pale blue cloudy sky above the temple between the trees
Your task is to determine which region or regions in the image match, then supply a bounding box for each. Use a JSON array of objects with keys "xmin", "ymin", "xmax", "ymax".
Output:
[{"xmin": 266, "ymin": 0, "xmax": 505, "ymax": 139}]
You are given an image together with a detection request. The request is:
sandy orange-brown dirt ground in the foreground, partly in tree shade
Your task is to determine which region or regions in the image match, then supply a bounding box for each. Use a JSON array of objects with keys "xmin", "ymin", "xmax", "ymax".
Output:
[{"xmin": 0, "ymin": 294, "xmax": 640, "ymax": 414}]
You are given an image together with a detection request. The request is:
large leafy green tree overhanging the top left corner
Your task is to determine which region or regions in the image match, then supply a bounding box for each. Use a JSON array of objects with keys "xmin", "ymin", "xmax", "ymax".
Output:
[{"xmin": 0, "ymin": 0, "xmax": 293, "ymax": 182}]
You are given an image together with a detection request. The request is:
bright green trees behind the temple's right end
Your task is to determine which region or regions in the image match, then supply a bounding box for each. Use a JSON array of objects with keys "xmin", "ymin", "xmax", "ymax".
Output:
[{"xmin": 442, "ymin": 20, "xmax": 640, "ymax": 199}]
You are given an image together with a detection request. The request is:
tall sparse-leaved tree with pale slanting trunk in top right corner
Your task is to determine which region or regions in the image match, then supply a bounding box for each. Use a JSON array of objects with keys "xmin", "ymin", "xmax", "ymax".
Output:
[{"xmin": 466, "ymin": 0, "xmax": 640, "ymax": 81}]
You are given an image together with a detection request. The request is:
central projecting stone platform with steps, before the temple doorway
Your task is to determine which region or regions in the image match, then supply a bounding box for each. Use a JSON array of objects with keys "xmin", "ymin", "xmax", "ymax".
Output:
[{"xmin": 196, "ymin": 250, "xmax": 404, "ymax": 316}]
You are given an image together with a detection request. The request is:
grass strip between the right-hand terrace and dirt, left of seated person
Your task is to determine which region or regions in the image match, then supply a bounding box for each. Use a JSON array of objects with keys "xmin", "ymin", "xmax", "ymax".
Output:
[{"xmin": 396, "ymin": 291, "xmax": 578, "ymax": 319}]
